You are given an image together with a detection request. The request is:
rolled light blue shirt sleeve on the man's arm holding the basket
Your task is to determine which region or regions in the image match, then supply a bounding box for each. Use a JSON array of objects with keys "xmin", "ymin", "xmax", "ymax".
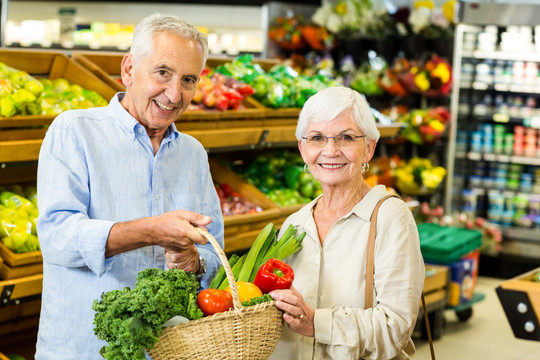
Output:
[{"xmin": 37, "ymin": 118, "xmax": 114, "ymax": 275}]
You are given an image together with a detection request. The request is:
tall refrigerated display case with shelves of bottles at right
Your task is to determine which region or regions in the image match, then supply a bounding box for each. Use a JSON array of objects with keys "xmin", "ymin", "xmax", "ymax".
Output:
[{"xmin": 445, "ymin": 1, "xmax": 540, "ymax": 262}]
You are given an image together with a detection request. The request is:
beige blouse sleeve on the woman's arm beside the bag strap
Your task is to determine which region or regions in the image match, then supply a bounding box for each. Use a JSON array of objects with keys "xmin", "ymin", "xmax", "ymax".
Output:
[{"xmin": 314, "ymin": 199, "xmax": 425, "ymax": 359}]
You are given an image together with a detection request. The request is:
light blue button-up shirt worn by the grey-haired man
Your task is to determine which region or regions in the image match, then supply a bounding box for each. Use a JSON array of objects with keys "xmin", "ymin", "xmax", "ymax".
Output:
[{"xmin": 35, "ymin": 93, "xmax": 223, "ymax": 360}]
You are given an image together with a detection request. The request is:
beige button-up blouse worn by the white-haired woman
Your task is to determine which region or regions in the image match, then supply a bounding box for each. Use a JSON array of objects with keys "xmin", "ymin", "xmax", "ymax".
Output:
[{"xmin": 271, "ymin": 185, "xmax": 425, "ymax": 360}]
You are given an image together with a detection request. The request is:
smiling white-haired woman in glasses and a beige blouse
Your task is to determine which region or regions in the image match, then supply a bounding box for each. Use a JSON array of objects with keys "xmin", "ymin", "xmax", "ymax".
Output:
[{"xmin": 271, "ymin": 87, "xmax": 425, "ymax": 360}]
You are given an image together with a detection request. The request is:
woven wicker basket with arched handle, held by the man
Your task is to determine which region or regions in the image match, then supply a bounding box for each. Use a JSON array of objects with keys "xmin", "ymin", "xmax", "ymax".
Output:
[{"xmin": 148, "ymin": 230, "xmax": 283, "ymax": 360}]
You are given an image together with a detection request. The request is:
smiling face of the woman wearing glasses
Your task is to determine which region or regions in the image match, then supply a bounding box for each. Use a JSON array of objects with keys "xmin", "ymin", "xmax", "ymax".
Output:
[{"xmin": 298, "ymin": 113, "xmax": 376, "ymax": 187}]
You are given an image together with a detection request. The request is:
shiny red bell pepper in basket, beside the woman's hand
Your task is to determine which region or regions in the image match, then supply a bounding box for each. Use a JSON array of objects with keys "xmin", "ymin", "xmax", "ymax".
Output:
[{"xmin": 253, "ymin": 259, "xmax": 294, "ymax": 294}]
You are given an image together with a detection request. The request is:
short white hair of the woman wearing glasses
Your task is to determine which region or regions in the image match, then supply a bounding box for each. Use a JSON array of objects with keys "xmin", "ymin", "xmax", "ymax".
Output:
[{"xmin": 296, "ymin": 86, "xmax": 380, "ymax": 141}]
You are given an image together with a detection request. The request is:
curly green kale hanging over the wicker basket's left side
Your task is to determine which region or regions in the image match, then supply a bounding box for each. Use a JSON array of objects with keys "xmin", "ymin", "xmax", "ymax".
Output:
[{"xmin": 92, "ymin": 268, "xmax": 203, "ymax": 360}]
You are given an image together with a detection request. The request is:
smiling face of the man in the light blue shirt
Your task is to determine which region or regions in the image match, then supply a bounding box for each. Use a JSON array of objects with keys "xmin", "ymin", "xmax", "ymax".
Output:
[{"xmin": 122, "ymin": 32, "xmax": 204, "ymax": 136}]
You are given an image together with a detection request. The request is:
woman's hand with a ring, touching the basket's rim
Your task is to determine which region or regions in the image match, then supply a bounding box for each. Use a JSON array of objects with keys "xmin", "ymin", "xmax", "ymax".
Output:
[{"xmin": 270, "ymin": 286, "xmax": 315, "ymax": 337}]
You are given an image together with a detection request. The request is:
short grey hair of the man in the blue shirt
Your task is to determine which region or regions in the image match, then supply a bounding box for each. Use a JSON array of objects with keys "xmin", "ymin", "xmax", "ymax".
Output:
[{"xmin": 129, "ymin": 13, "xmax": 208, "ymax": 66}]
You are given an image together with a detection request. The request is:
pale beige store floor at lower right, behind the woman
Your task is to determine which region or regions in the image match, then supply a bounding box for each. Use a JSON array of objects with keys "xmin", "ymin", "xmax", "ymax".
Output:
[{"xmin": 414, "ymin": 277, "xmax": 540, "ymax": 360}]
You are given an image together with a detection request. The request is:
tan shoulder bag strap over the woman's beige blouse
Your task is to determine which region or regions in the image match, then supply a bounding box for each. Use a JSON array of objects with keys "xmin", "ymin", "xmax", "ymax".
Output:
[{"xmin": 364, "ymin": 194, "xmax": 435, "ymax": 360}]
